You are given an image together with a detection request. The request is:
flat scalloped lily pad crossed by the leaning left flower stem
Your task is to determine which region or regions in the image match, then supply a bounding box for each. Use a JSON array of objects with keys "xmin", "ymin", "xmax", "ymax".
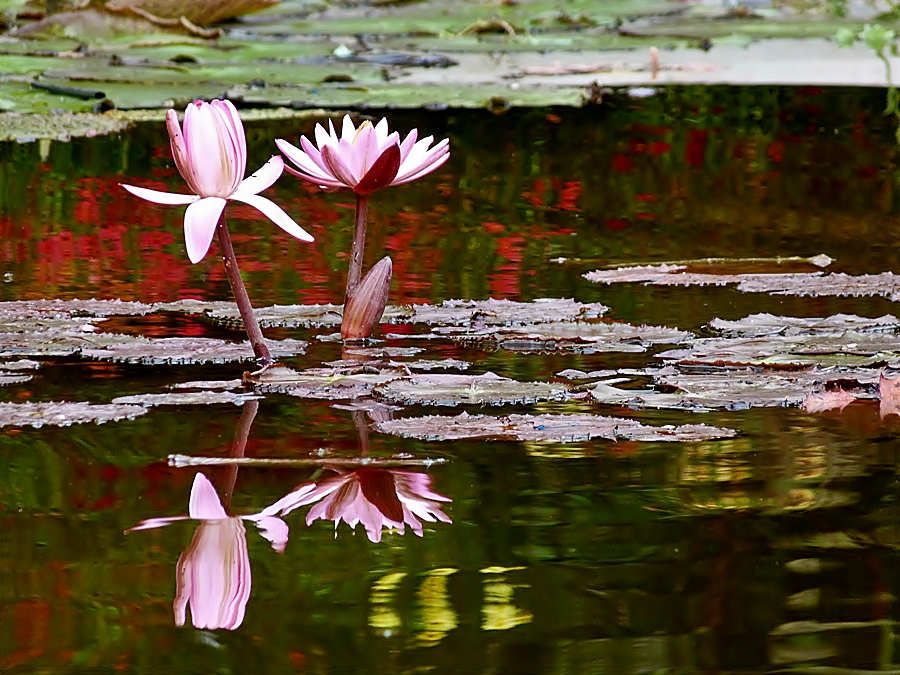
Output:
[{"xmin": 81, "ymin": 336, "xmax": 306, "ymax": 365}]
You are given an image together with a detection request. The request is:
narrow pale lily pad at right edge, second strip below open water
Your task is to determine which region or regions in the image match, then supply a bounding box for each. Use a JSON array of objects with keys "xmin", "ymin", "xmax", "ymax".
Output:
[{"xmin": 709, "ymin": 314, "xmax": 900, "ymax": 337}]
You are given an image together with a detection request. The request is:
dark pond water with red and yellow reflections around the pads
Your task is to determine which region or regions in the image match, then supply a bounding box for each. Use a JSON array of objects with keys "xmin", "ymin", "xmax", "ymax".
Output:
[{"xmin": 0, "ymin": 88, "xmax": 900, "ymax": 674}]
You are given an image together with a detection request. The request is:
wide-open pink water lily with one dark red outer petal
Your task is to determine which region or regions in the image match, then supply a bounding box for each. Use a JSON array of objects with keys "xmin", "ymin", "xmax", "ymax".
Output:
[{"xmin": 275, "ymin": 115, "xmax": 450, "ymax": 195}]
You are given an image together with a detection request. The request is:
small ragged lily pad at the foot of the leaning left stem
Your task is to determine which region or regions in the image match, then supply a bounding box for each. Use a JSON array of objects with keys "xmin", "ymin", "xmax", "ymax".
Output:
[{"xmin": 248, "ymin": 365, "xmax": 404, "ymax": 401}]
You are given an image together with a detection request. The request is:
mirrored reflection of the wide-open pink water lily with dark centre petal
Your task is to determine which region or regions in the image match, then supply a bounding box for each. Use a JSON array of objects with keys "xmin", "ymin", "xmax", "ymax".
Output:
[{"xmin": 267, "ymin": 469, "xmax": 452, "ymax": 542}]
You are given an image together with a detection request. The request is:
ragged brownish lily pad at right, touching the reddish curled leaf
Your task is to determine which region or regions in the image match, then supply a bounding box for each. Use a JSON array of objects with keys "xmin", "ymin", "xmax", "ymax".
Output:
[{"xmin": 591, "ymin": 368, "xmax": 879, "ymax": 412}]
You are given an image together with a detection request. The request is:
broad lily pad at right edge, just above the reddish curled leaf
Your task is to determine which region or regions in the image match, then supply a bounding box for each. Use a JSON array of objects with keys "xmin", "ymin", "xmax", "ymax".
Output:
[{"xmin": 657, "ymin": 331, "xmax": 900, "ymax": 368}]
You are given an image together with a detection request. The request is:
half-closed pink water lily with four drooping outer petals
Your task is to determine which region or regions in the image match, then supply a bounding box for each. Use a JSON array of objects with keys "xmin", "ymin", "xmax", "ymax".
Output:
[{"xmin": 122, "ymin": 101, "xmax": 313, "ymax": 263}]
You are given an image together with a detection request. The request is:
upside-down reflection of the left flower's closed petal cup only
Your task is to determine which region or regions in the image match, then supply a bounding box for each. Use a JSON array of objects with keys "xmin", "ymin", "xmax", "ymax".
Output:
[{"xmin": 173, "ymin": 518, "xmax": 250, "ymax": 630}]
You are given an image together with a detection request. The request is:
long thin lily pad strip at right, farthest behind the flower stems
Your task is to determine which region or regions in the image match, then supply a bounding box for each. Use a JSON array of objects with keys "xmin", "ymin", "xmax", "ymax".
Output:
[{"xmin": 584, "ymin": 265, "xmax": 900, "ymax": 301}]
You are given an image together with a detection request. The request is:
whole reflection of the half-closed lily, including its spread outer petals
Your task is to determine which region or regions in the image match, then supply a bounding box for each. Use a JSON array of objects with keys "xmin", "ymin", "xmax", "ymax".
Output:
[{"xmin": 129, "ymin": 473, "xmax": 288, "ymax": 630}]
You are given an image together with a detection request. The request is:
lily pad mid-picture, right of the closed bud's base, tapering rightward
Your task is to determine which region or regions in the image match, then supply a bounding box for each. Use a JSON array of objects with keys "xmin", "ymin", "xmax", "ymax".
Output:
[{"xmin": 434, "ymin": 322, "xmax": 694, "ymax": 353}]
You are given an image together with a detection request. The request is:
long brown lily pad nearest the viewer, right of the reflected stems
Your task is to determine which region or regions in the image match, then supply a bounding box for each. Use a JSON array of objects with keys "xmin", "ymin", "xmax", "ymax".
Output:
[{"xmin": 375, "ymin": 413, "xmax": 736, "ymax": 443}]
